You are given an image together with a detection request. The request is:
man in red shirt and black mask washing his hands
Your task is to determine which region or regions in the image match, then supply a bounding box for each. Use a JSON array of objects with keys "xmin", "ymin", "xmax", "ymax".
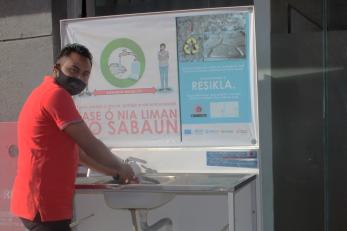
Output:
[{"xmin": 11, "ymin": 44, "xmax": 136, "ymax": 231}]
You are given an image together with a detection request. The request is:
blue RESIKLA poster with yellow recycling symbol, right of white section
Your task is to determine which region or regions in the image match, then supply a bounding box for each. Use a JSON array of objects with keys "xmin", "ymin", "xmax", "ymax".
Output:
[{"xmin": 176, "ymin": 11, "xmax": 257, "ymax": 146}]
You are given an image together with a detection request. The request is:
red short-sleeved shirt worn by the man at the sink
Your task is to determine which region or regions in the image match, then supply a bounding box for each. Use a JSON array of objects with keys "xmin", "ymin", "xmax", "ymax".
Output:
[{"xmin": 11, "ymin": 76, "xmax": 82, "ymax": 221}]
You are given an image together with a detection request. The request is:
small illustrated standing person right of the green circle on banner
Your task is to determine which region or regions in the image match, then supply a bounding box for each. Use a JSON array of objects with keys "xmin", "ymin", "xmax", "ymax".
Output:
[{"xmin": 158, "ymin": 43, "xmax": 169, "ymax": 90}]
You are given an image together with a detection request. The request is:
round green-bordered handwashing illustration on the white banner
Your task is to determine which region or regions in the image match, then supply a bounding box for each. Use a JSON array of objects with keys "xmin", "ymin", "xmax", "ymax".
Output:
[{"xmin": 100, "ymin": 38, "xmax": 145, "ymax": 88}]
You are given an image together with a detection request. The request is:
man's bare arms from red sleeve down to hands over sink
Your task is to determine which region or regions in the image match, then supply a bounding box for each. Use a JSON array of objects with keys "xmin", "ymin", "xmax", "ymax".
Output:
[{"xmin": 63, "ymin": 121, "xmax": 135, "ymax": 183}]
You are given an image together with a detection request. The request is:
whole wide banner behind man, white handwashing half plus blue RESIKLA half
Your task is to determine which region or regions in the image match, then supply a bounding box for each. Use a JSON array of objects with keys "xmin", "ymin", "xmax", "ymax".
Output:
[{"xmin": 61, "ymin": 7, "xmax": 259, "ymax": 147}]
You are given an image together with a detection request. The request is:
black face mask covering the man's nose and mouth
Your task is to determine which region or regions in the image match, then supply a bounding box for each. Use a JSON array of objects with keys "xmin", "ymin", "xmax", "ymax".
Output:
[{"xmin": 55, "ymin": 69, "xmax": 87, "ymax": 95}]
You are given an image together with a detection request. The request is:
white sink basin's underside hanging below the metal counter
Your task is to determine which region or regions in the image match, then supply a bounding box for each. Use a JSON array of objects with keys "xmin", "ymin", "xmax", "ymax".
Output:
[{"xmin": 104, "ymin": 191, "xmax": 175, "ymax": 209}]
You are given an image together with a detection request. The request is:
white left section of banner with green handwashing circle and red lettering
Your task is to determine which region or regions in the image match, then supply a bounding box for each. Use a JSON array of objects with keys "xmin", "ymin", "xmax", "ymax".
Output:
[{"xmin": 62, "ymin": 15, "xmax": 181, "ymax": 147}]
